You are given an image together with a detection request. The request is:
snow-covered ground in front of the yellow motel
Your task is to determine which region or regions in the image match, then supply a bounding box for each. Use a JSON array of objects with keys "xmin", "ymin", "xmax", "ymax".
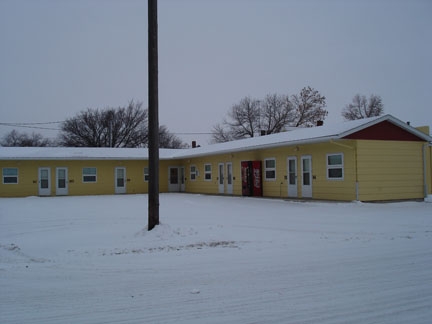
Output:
[{"xmin": 0, "ymin": 194, "xmax": 432, "ymax": 324}]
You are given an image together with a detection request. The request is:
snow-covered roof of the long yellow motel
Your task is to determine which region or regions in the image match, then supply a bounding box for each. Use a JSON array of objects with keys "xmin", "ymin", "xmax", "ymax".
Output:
[{"xmin": 0, "ymin": 115, "xmax": 432, "ymax": 160}]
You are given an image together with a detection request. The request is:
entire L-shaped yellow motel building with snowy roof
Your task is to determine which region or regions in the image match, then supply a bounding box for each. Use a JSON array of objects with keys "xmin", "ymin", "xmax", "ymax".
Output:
[{"xmin": 0, "ymin": 115, "xmax": 432, "ymax": 201}]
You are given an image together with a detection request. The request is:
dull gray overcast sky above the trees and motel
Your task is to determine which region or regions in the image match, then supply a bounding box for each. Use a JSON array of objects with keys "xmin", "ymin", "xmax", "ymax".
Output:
[{"xmin": 0, "ymin": 0, "xmax": 432, "ymax": 145}]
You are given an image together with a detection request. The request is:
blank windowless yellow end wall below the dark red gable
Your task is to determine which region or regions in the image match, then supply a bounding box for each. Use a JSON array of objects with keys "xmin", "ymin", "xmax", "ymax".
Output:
[{"xmin": 357, "ymin": 140, "xmax": 424, "ymax": 201}]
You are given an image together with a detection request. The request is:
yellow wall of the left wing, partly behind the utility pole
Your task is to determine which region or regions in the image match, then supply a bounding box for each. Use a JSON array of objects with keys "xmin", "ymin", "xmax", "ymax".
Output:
[{"xmin": 0, "ymin": 160, "xmax": 176, "ymax": 197}]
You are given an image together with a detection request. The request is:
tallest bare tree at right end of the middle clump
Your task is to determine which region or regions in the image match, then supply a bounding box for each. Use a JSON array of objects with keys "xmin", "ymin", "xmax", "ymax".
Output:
[{"xmin": 291, "ymin": 87, "xmax": 328, "ymax": 127}]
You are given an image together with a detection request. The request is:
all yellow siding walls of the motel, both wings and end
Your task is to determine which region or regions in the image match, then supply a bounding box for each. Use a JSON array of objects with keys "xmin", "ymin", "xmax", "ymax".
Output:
[{"xmin": 0, "ymin": 140, "xmax": 432, "ymax": 201}]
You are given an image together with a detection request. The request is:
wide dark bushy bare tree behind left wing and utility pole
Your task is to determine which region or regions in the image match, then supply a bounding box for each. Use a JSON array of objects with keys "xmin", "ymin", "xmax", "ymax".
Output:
[{"xmin": 59, "ymin": 101, "xmax": 184, "ymax": 148}]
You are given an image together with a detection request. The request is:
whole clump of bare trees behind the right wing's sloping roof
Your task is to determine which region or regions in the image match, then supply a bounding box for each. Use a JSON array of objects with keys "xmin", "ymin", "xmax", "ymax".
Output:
[{"xmin": 212, "ymin": 87, "xmax": 328, "ymax": 143}]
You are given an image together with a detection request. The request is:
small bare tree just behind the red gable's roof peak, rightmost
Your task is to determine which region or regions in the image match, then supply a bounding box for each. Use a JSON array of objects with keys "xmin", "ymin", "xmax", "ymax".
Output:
[{"xmin": 342, "ymin": 94, "xmax": 384, "ymax": 120}]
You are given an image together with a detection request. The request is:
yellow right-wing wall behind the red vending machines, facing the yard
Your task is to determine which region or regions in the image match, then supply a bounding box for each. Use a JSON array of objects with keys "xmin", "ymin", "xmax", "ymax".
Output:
[{"xmin": 180, "ymin": 140, "xmax": 356, "ymax": 200}]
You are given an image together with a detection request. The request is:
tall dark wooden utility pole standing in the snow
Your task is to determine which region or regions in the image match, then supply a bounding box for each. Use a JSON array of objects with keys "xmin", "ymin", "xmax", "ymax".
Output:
[{"xmin": 148, "ymin": 0, "xmax": 159, "ymax": 231}]
